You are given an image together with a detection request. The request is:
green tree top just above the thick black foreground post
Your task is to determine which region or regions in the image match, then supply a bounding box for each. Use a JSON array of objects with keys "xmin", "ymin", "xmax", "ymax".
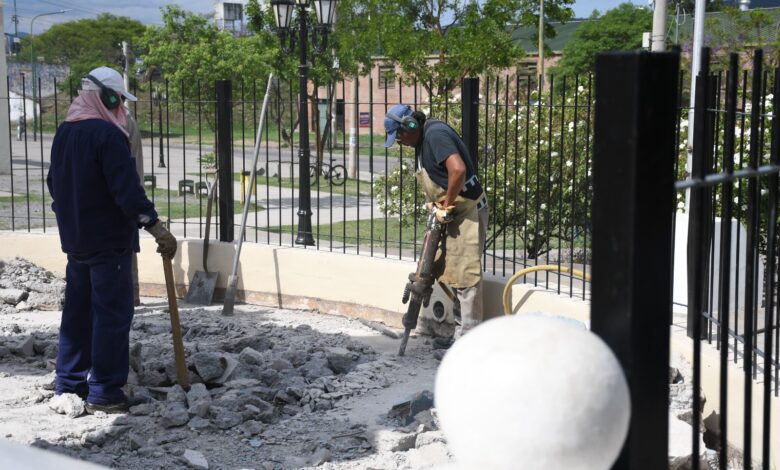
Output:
[{"xmin": 554, "ymin": 3, "xmax": 653, "ymax": 75}]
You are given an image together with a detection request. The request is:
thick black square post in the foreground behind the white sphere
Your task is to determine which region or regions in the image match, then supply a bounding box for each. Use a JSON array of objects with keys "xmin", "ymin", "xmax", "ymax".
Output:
[{"xmin": 591, "ymin": 52, "xmax": 679, "ymax": 470}]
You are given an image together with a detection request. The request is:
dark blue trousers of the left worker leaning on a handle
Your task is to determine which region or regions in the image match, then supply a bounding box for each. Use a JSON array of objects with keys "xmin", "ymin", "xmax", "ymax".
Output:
[{"xmin": 56, "ymin": 250, "xmax": 133, "ymax": 404}]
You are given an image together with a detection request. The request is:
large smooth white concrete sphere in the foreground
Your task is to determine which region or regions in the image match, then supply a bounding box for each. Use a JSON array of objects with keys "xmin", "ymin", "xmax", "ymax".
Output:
[{"xmin": 435, "ymin": 315, "xmax": 631, "ymax": 470}]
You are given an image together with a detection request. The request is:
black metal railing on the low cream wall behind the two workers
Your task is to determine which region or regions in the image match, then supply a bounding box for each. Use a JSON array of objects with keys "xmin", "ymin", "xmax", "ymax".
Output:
[{"xmin": 0, "ymin": 68, "xmax": 592, "ymax": 298}]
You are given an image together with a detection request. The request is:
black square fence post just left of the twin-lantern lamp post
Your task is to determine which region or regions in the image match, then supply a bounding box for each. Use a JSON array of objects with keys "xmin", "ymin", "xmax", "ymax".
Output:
[{"xmin": 216, "ymin": 80, "xmax": 233, "ymax": 242}]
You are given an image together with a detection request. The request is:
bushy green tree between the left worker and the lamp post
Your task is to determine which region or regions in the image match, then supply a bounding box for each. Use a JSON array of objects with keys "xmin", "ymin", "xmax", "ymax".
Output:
[{"xmin": 143, "ymin": 5, "xmax": 275, "ymax": 129}]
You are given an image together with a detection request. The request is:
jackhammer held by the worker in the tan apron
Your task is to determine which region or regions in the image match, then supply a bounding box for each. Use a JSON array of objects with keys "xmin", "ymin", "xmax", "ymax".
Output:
[{"xmin": 398, "ymin": 206, "xmax": 445, "ymax": 356}]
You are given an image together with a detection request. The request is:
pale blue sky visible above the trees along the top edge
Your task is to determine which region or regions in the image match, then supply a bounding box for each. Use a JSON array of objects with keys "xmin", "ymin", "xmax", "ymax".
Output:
[{"xmin": 7, "ymin": 0, "xmax": 647, "ymax": 34}]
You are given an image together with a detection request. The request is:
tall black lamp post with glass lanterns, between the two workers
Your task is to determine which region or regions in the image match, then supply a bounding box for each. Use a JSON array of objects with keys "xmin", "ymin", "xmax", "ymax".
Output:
[{"xmin": 271, "ymin": 0, "xmax": 337, "ymax": 245}]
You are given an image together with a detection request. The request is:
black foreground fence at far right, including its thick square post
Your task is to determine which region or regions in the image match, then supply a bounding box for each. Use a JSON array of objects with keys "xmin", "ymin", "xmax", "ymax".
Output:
[{"xmin": 592, "ymin": 49, "xmax": 780, "ymax": 469}]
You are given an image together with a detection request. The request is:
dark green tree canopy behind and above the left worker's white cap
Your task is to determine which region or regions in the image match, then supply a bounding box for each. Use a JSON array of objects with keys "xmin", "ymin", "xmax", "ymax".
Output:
[{"xmin": 19, "ymin": 13, "xmax": 146, "ymax": 83}]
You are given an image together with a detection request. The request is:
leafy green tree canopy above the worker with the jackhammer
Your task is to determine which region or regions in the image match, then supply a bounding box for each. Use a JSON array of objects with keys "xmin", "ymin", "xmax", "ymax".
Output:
[{"xmin": 339, "ymin": 0, "xmax": 574, "ymax": 96}]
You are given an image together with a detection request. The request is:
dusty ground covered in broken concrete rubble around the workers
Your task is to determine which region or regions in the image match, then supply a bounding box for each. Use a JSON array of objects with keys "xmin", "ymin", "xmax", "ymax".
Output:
[{"xmin": 0, "ymin": 260, "xmax": 450, "ymax": 469}]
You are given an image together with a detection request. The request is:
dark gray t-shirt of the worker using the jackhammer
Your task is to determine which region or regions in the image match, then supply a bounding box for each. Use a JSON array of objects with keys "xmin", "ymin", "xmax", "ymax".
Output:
[{"xmin": 415, "ymin": 119, "xmax": 482, "ymax": 200}]
